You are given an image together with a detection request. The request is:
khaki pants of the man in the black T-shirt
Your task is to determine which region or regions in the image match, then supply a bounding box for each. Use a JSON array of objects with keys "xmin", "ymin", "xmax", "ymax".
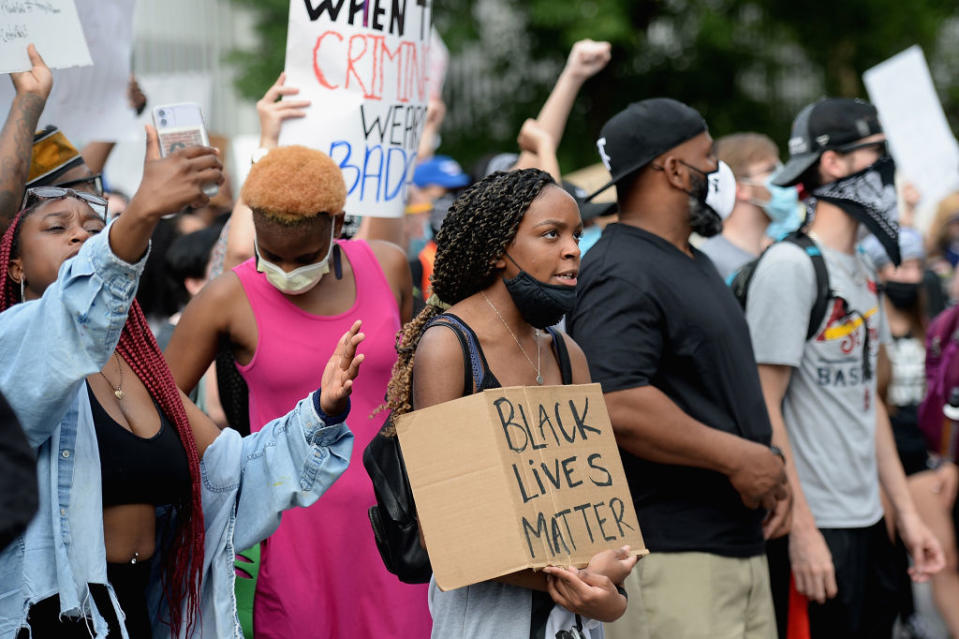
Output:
[{"xmin": 606, "ymin": 552, "xmax": 776, "ymax": 639}]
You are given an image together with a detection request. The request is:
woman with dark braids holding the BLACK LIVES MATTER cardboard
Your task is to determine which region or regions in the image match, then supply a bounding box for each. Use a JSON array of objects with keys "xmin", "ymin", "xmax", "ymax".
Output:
[{"xmin": 388, "ymin": 169, "xmax": 636, "ymax": 637}]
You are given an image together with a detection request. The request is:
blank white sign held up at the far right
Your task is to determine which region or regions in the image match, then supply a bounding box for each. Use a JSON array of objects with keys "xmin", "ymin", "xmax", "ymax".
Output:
[{"xmin": 863, "ymin": 46, "xmax": 959, "ymax": 228}]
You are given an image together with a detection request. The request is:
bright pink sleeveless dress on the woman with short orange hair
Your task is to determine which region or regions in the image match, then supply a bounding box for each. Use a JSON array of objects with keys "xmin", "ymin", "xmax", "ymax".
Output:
[{"xmin": 233, "ymin": 241, "xmax": 431, "ymax": 639}]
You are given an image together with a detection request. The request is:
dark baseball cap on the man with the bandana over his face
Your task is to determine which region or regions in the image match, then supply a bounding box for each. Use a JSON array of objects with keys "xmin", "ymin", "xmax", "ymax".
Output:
[{"xmin": 773, "ymin": 98, "xmax": 882, "ymax": 186}]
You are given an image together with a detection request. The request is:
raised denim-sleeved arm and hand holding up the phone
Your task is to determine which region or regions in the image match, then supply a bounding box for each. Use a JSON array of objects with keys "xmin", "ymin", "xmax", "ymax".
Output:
[{"xmin": 0, "ymin": 129, "xmax": 223, "ymax": 446}]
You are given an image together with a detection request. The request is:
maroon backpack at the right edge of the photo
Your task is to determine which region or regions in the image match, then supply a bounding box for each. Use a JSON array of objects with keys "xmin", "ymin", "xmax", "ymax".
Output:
[{"xmin": 919, "ymin": 306, "xmax": 959, "ymax": 455}]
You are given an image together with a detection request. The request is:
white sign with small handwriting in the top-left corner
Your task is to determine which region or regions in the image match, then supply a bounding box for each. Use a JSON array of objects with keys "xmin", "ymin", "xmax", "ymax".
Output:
[{"xmin": 0, "ymin": 0, "xmax": 93, "ymax": 73}]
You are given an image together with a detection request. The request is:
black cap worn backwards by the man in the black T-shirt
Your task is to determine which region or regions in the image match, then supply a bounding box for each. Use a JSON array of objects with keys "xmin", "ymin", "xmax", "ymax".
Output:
[{"xmin": 587, "ymin": 98, "xmax": 706, "ymax": 200}]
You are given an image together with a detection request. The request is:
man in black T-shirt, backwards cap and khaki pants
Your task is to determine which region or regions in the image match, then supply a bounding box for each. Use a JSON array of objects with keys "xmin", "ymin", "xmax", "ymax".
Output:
[{"xmin": 567, "ymin": 98, "xmax": 789, "ymax": 639}]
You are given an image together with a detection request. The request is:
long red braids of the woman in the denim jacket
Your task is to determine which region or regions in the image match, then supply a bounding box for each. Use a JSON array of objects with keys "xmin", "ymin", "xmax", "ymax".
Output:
[{"xmin": 0, "ymin": 204, "xmax": 204, "ymax": 635}]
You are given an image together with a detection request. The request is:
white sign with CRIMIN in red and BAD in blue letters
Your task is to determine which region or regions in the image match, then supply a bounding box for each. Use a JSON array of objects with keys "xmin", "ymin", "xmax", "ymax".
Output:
[{"xmin": 280, "ymin": 0, "xmax": 432, "ymax": 217}]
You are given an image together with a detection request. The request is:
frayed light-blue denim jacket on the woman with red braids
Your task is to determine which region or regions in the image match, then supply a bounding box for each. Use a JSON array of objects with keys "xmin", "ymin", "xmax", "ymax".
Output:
[{"xmin": 0, "ymin": 227, "xmax": 353, "ymax": 639}]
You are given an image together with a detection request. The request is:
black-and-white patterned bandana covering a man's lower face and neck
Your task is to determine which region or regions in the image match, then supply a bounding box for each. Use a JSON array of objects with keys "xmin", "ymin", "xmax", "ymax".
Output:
[{"xmin": 812, "ymin": 157, "xmax": 902, "ymax": 266}]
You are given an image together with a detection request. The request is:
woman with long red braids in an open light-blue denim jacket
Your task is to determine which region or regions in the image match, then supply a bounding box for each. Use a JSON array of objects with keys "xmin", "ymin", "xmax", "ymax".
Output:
[{"xmin": 0, "ymin": 127, "xmax": 363, "ymax": 639}]
